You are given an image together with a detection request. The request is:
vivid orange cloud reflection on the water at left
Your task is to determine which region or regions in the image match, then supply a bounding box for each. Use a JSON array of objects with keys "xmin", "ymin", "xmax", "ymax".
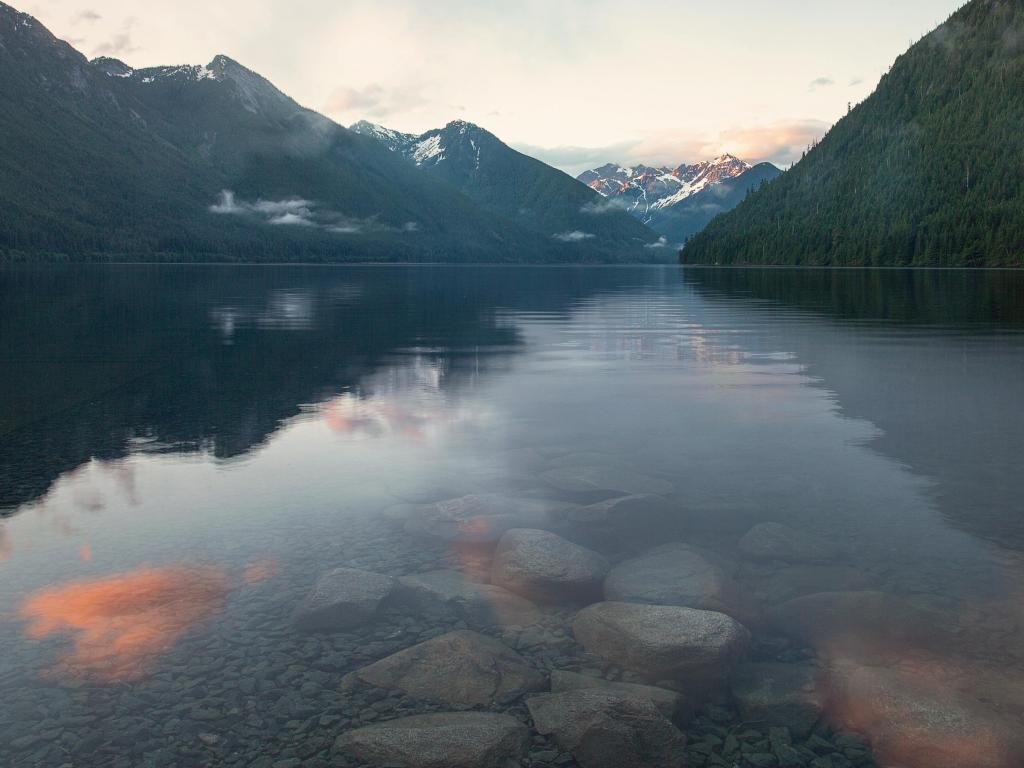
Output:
[{"xmin": 20, "ymin": 565, "xmax": 228, "ymax": 681}]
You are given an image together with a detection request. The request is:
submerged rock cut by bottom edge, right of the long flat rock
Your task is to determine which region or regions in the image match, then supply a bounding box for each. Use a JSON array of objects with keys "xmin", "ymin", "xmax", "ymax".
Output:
[{"xmin": 526, "ymin": 690, "xmax": 685, "ymax": 768}]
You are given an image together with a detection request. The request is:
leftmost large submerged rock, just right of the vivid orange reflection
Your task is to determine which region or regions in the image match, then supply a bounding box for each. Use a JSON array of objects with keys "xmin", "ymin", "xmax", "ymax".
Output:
[{"xmin": 294, "ymin": 568, "xmax": 395, "ymax": 632}]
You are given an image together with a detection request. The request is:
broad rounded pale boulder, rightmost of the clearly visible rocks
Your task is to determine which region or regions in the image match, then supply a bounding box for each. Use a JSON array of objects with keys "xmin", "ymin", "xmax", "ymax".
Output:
[{"xmin": 572, "ymin": 602, "xmax": 751, "ymax": 690}]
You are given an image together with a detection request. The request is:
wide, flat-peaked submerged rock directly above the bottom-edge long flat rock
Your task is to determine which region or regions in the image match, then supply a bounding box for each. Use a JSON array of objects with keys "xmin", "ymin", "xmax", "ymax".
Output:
[{"xmin": 343, "ymin": 630, "xmax": 547, "ymax": 707}]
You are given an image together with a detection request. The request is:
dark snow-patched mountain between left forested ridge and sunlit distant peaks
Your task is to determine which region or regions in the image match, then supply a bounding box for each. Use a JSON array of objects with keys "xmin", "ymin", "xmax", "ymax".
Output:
[{"xmin": 351, "ymin": 120, "xmax": 659, "ymax": 256}]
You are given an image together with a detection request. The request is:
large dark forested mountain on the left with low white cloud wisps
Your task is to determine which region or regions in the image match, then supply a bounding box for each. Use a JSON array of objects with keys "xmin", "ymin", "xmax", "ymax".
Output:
[{"xmin": 0, "ymin": 3, "xmax": 655, "ymax": 261}]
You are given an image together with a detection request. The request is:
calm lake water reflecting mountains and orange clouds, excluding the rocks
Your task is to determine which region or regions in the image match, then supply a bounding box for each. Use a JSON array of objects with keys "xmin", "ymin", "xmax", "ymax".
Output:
[{"xmin": 0, "ymin": 266, "xmax": 1024, "ymax": 768}]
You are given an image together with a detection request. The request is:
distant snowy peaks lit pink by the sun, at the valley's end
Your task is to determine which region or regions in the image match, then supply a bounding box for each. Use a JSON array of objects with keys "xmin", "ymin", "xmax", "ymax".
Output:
[{"xmin": 577, "ymin": 155, "xmax": 781, "ymax": 244}]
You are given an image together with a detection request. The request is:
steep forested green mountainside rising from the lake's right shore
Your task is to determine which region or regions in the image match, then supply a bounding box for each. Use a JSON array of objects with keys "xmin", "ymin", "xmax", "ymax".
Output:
[{"xmin": 680, "ymin": 0, "xmax": 1024, "ymax": 266}]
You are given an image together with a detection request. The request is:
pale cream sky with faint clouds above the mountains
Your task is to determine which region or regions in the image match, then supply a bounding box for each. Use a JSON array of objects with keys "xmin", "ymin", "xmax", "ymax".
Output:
[{"xmin": 25, "ymin": 0, "xmax": 963, "ymax": 174}]
